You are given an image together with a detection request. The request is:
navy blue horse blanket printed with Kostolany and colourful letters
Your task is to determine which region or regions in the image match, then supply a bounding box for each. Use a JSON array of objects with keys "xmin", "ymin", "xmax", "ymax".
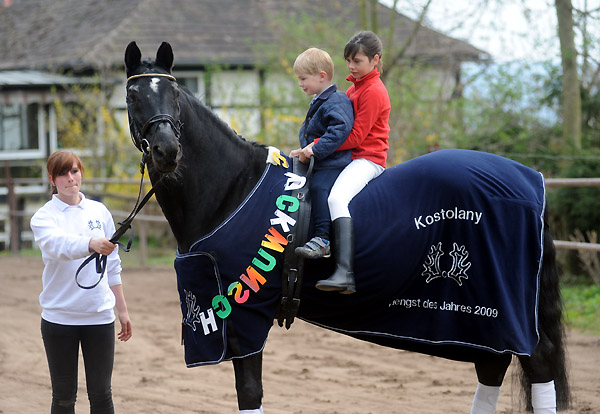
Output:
[{"xmin": 175, "ymin": 150, "xmax": 545, "ymax": 367}]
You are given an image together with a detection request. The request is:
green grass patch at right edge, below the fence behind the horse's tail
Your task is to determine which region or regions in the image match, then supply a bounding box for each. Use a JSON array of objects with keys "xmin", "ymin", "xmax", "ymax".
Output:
[{"xmin": 561, "ymin": 284, "xmax": 600, "ymax": 335}]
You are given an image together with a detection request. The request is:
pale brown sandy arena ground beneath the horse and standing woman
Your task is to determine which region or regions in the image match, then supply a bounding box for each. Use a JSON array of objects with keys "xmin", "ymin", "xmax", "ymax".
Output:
[{"xmin": 0, "ymin": 257, "xmax": 600, "ymax": 414}]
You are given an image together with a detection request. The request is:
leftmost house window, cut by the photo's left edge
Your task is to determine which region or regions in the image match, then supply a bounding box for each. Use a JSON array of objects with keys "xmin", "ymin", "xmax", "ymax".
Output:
[{"xmin": 0, "ymin": 103, "xmax": 39, "ymax": 151}]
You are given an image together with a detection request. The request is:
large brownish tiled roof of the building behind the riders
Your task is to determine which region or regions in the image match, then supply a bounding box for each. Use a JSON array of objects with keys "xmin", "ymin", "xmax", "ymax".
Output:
[{"xmin": 0, "ymin": 0, "xmax": 488, "ymax": 71}]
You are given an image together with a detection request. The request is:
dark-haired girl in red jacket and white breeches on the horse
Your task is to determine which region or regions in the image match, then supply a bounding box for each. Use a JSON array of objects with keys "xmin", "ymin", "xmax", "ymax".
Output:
[{"xmin": 316, "ymin": 31, "xmax": 391, "ymax": 293}]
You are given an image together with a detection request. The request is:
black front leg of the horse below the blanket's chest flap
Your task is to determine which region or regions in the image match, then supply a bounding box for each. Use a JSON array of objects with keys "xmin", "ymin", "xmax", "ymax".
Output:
[{"xmin": 233, "ymin": 352, "xmax": 263, "ymax": 414}]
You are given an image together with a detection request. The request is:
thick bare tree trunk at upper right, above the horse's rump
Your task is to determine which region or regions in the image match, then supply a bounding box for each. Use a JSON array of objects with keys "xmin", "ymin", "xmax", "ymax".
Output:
[{"xmin": 555, "ymin": 0, "xmax": 581, "ymax": 149}]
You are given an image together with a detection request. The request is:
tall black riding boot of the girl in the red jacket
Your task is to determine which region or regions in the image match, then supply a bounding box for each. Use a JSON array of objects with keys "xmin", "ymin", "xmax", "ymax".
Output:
[{"xmin": 316, "ymin": 217, "xmax": 356, "ymax": 294}]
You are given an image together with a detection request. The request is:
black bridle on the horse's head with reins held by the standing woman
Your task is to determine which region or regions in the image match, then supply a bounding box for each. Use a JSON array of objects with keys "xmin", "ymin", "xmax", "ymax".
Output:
[{"xmin": 75, "ymin": 73, "xmax": 183, "ymax": 289}]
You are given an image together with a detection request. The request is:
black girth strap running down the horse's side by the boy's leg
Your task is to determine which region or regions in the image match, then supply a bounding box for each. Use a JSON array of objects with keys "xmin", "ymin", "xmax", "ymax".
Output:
[{"xmin": 277, "ymin": 158, "xmax": 314, "ymax": 329}]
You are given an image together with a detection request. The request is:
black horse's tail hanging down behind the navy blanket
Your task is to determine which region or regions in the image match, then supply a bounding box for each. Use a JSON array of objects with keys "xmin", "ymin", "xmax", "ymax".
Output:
[{"xmin": 520, "ymin": 209, "xmax": 571, "ymax": 411}]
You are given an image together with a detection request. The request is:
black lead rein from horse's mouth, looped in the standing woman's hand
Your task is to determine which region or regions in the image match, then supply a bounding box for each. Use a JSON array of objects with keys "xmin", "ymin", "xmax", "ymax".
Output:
[{"xmin": 75, "ymin": 160, "xmax": 163, "ymax": 289}]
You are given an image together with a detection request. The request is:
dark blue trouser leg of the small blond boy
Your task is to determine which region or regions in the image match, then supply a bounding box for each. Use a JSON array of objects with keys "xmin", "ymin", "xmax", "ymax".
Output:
[{"xmin": 310, "ymin": 168, "xmax": 344, "ymax": 241}]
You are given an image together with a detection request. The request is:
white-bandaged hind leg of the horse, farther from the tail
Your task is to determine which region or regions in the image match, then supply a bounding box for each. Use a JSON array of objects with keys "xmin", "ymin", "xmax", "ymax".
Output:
[{"xmin": 471, "ymin": 355, "xmax": 512, "ymax": 414}]
